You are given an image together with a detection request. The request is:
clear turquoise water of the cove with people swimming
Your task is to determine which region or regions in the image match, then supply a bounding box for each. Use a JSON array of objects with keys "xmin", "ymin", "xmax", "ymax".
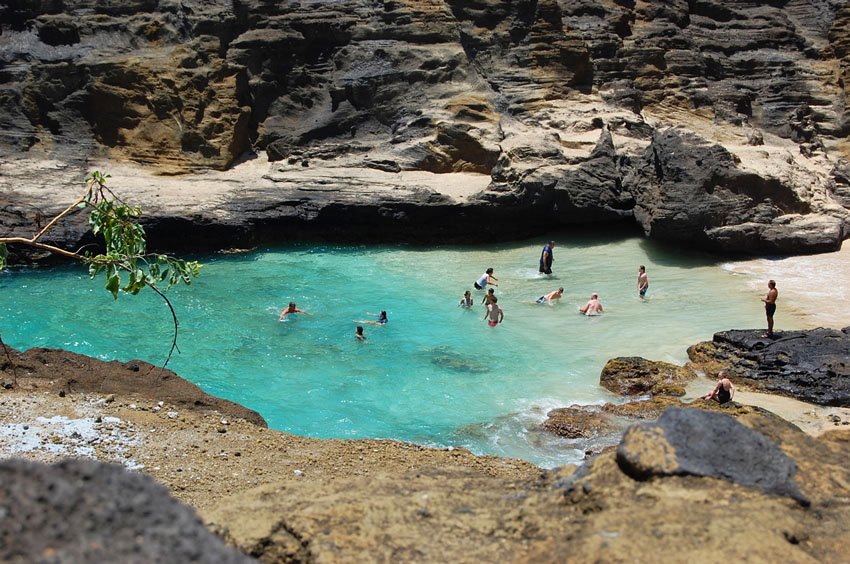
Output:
[{"xmin": 0, "ymin": 235, "xmax": 776, "ymax": 466}]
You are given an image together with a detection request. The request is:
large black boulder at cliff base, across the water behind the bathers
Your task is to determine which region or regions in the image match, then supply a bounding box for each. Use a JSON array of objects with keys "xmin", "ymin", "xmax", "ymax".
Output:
[{"xmin": 625, "ymin": 129, "xmax": 844, "ymax": 253}]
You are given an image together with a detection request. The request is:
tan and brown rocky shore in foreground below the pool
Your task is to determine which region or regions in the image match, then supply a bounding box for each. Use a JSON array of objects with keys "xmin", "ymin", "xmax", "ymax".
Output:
[{"xmin": 0, "ymin": 332, "xmax": 850, "ymax": 562}]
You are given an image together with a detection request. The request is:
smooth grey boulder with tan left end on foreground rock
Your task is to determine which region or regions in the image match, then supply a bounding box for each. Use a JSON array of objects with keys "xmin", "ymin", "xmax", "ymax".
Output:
[{"xmin": 617, "ymin": 407, "xmax": 809, "ymax": 505}]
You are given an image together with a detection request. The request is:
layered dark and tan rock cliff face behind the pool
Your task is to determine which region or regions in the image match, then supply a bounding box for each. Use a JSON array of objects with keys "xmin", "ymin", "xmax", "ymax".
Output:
[{"xmin": 0, "ymin": 0, "xmax": 850, "ymax": 252}]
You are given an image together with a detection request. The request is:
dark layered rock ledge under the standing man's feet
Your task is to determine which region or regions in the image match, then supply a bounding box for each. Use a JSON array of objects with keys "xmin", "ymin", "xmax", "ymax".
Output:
[{"xmin": 688, "ymin": 327, "xmax": 850, "ymax": 407}]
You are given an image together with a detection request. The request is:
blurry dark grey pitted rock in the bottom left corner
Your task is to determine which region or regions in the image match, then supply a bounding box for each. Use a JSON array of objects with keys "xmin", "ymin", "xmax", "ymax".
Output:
[{"xmin": 0, "ymin": 460, "xmax": 255, "ymax": 563}]
